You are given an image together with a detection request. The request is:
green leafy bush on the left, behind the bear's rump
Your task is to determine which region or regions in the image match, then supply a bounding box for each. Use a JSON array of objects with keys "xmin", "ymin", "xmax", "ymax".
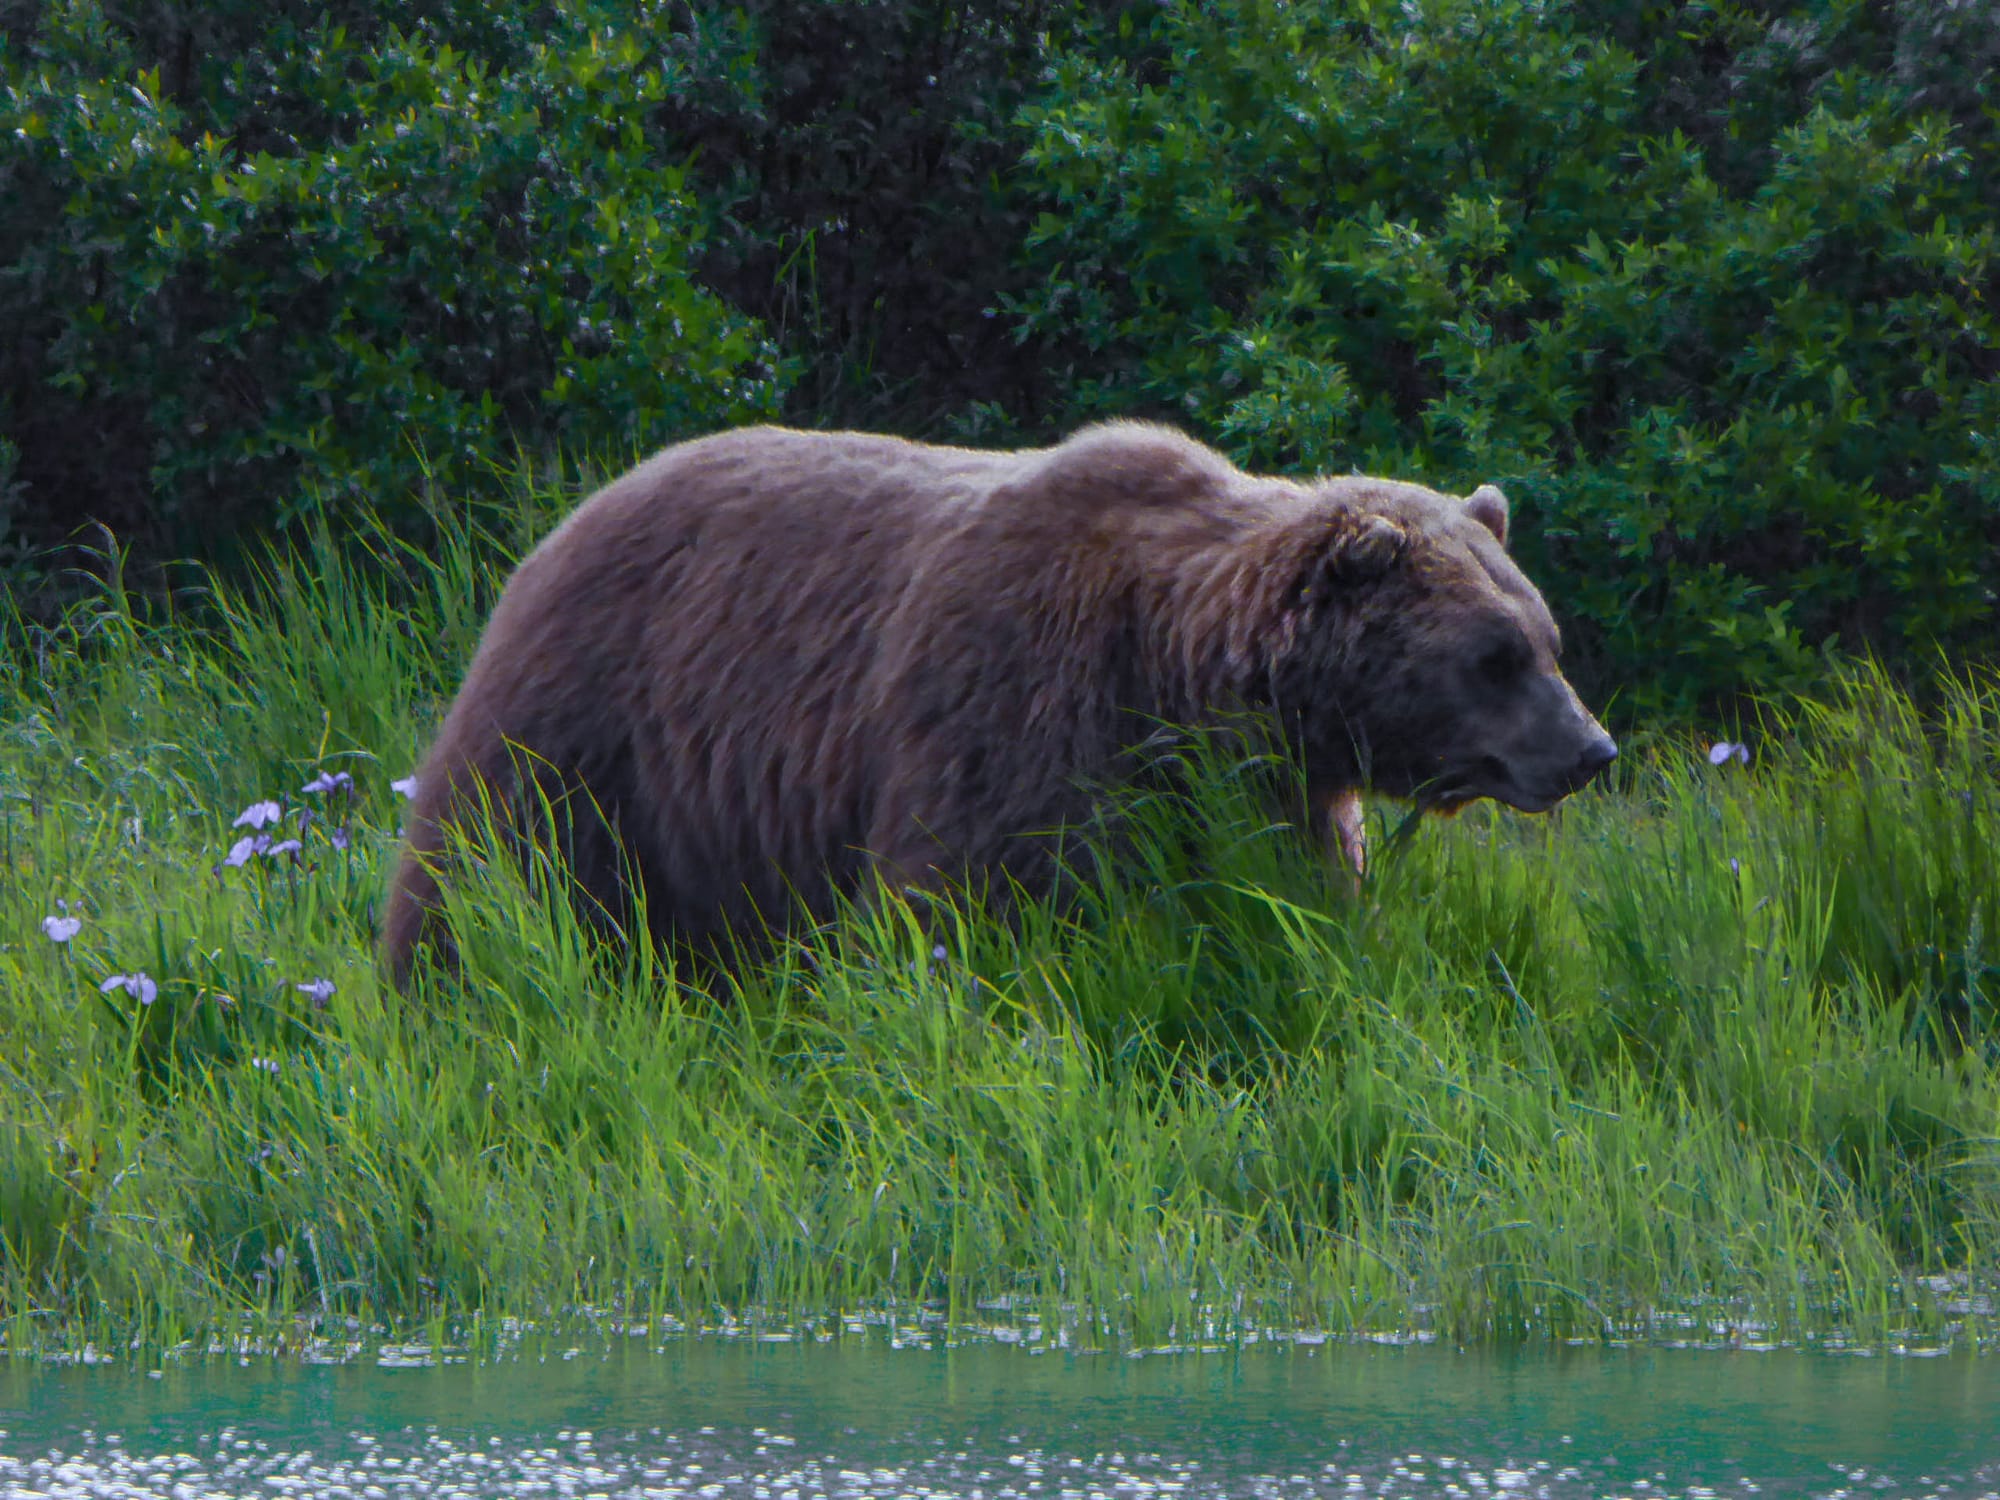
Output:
[{"xmin": 0, "ymin": 0, "xmax": 784, "ymax": 568}]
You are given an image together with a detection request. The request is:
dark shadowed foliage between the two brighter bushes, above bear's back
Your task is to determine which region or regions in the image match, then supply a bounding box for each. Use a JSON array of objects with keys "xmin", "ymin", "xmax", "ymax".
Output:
[{"xmin": 662, "ymin": 0, "xmax": 1122, "ymax": 436}]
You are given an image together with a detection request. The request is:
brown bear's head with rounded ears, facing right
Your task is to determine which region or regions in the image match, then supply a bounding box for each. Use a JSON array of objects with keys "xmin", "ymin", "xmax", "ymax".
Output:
[{"xmin": 1266, "ymin": 478, "xmax": 1618, "ymax": 812}]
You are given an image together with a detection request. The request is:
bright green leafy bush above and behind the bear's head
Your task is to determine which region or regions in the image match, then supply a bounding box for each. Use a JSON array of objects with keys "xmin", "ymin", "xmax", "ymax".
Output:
[{"xmin": 1016, "ymin": 0, "xmax": 2000, "ymax": 708}]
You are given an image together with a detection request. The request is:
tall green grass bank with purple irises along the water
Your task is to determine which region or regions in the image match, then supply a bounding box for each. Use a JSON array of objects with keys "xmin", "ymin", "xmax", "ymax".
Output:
[{"xmin": 0, "ymin": 496, "xmax": 2000, "ymax": 1348}]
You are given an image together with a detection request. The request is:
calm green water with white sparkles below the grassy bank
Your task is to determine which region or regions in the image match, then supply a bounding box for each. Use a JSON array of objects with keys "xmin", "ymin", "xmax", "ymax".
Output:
[{"xmin": 0, "ymin": 1342, "xmax": 2000, "ymax": 1500}]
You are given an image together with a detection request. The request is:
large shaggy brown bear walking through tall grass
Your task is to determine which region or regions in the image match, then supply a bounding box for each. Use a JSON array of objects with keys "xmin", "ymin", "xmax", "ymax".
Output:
[{"xmin": 382, "ymin": 422, "xmax": 1618, "ymax": 984}]
